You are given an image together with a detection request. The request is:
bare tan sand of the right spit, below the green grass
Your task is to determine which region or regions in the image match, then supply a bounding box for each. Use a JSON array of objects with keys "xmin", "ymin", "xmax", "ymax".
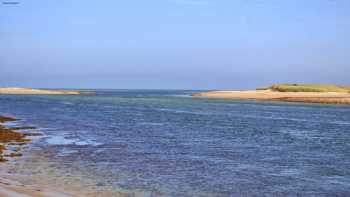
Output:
[{"xmin": 192, "ymin": 90, "xmax": 350, "ymax": 104}]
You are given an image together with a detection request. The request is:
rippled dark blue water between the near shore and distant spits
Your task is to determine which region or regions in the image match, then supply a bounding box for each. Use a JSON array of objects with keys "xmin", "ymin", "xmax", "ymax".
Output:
[{"xmin": 0, "ymin": 90, "xmax": 350, "ymax": 196}]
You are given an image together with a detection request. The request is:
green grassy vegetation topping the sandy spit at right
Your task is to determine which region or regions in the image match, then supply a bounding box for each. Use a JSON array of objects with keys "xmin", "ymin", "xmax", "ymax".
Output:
[{"xmin": 257, "ymin": 84, "xmax": 350, "ymax": 93}]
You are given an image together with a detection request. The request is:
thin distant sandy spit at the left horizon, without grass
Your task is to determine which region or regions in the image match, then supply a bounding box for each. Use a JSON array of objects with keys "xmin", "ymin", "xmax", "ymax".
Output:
[{"xmin": 0, "ymin": 88, "xmax": 80, "ymax": 94}]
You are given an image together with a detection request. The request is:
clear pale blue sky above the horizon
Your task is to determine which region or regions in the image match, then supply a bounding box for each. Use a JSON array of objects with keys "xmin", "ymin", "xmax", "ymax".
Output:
[{"xmin": 0, "ymin": 0, "xmax": 350, "ymax": 89}]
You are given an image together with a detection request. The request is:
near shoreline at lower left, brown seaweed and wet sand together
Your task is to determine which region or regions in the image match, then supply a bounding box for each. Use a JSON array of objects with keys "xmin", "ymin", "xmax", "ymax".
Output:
[{"xmin": 0, "ymin": 116, "xmax": 133, "ymax": 197}]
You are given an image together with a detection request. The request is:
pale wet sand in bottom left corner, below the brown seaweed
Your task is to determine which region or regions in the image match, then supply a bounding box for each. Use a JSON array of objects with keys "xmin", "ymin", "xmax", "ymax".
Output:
[{"xmin": 0, "ymin": 153, "xmax": 127, "ymax": 197}]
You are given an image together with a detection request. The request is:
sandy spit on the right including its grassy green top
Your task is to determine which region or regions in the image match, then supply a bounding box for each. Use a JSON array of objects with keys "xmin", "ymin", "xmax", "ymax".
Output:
[{"xmin": 192, "ymin": 84, "xmax": 350, "ymax": 104}]
